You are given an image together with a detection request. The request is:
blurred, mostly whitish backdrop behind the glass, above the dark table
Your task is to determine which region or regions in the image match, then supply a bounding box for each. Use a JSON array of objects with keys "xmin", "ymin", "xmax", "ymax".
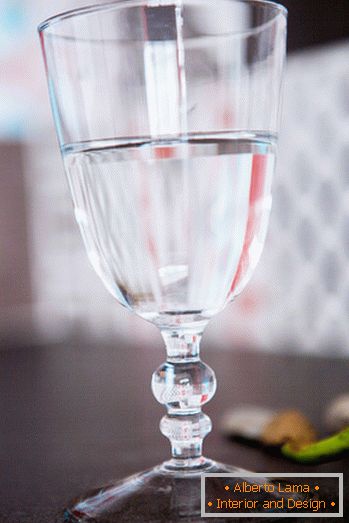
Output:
[{"xmin": 0, "ymin": 0, "xmax": 349, "ymax": 355}]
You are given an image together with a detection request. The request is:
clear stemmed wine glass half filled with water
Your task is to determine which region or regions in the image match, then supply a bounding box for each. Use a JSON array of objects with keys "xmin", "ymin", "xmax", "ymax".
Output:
[{"xmin": 39, "ymin": 0, "xmax": 286, "ymax": 522}]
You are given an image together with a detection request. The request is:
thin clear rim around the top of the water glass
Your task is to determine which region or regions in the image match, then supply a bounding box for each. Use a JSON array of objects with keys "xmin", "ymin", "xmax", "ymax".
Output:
[{"xmin": 37, "ymin": 0, "xmax": 288, "ymax": 40}]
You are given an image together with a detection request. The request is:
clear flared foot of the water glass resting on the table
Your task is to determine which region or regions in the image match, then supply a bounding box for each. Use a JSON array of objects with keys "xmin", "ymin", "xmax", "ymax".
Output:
[{"xmin": 64, "ymin": 459, "xmax": 290, "ymax": 523}]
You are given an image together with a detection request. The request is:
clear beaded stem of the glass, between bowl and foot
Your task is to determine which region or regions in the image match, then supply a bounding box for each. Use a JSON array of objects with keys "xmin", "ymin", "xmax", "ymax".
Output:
[{"xmin": 152, "ymin": 327, "xmax": 216, "ymax": 470}]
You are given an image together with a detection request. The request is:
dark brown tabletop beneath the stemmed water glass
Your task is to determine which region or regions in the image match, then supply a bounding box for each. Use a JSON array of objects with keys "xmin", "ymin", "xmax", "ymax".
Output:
[{"xmin": 0, "ymin": 344, "xmax": 349, "ymax": 523}]
